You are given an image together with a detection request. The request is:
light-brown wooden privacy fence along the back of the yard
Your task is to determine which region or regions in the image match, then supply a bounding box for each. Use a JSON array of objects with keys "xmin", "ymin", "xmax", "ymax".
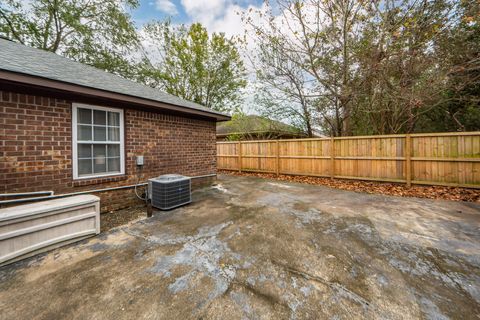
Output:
[{"xmin": 217, "ymin": 132, "xmax": 480, "ymax": 188}]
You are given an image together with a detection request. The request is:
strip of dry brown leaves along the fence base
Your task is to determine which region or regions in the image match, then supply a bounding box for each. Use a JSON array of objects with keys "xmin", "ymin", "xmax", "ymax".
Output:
[{"xmin": 219, "ymin": 170, "xmax": 480, "ymax": 202}]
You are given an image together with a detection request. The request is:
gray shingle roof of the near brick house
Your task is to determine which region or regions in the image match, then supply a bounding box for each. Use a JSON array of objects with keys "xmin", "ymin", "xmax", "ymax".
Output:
[{"xmin": 0, "ymin": 39, "xmax": 228, "ymax": 116}]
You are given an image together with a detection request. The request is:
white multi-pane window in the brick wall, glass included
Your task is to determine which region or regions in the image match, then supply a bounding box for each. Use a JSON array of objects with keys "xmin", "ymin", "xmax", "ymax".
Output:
[{"xmin": 72, "ymin": 103, "xmax": 125, "ymax": 179}]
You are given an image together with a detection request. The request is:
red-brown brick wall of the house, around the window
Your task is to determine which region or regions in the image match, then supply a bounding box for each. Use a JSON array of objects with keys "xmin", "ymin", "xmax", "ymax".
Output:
[{"xmin": 0, "ymin": 92, "xmax": 216, "ymax": 211}]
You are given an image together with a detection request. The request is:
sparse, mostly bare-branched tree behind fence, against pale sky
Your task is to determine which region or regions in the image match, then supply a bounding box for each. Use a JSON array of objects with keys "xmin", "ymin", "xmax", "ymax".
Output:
[{"xmin": 243, "ymin": 0, "xmax": 366, "ymax": 136}]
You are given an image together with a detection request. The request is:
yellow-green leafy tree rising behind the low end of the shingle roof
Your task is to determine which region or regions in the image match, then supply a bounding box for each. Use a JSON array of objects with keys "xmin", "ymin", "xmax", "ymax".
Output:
[{"xmin": 140, "ymin": 22, "xmax": 246, "ymax": 111}]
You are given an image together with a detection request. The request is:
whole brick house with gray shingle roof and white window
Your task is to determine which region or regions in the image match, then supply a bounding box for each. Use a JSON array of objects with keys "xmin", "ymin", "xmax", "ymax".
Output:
[{"xmin": 0, "ymin": 39, "xmax": 230, "ymax": 212}]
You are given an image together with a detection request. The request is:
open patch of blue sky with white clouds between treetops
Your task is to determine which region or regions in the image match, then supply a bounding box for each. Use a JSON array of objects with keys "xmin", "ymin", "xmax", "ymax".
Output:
[{"xmin": 132, "ymin": 0, "xmax": 263, "ymax": 36}]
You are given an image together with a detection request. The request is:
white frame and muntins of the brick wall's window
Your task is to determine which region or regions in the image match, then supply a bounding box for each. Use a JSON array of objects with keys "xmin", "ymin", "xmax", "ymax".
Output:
[{"xmin": 72, "ymin": 103, "xmax": 125, "ymax": 180}]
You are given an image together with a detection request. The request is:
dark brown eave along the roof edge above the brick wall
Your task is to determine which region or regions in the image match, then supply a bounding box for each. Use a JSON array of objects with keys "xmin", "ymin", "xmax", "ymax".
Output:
[{"xmin": 0, "ymin": 70, "xmax": 231, "ymax": 121}]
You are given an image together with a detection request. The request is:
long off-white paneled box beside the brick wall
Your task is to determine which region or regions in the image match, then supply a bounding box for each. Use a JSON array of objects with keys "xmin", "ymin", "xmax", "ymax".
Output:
[{"xmin": 0, "ymin": 195, "xmax": 100, "ymax": 265}]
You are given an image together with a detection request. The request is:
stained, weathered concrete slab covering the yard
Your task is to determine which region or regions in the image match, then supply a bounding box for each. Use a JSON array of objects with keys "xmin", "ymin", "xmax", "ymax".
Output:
[{"xmin": 0, "ymin": 176, "xmax": 480, "ymax": 320}]
